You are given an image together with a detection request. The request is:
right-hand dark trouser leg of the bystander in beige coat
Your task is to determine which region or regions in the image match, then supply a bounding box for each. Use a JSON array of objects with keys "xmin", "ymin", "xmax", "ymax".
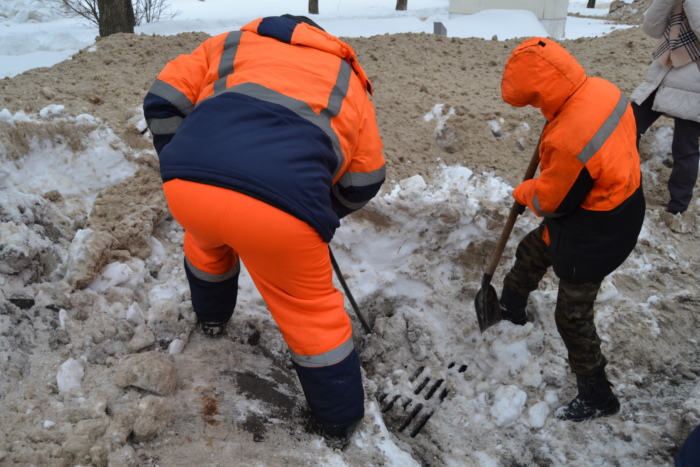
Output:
[{"xmin": 668, "ymin": 118, "xmax": 700, "ymax": 214}]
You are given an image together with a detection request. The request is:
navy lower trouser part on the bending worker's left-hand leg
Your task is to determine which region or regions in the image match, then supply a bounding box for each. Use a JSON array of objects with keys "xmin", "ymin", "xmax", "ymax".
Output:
[{"xmin": 185, "ymin": 258, "xmax": 240, "ymax": 332}]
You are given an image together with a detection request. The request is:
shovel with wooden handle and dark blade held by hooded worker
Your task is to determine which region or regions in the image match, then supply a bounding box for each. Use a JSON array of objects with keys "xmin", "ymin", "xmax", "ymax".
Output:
[{"xmin": 474, "ymin": 131, "xmax": 542, "ymax": 332}]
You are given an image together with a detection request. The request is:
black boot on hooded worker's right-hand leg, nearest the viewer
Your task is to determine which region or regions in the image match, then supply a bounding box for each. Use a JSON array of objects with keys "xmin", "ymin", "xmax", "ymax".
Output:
[{"xmin": 556, "ymin": 370, "xmax": 620, "ymax": 422}]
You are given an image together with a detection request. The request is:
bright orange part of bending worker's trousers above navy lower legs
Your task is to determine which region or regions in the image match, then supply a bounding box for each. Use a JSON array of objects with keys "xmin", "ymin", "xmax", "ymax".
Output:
[{"xmin": 163, "ymin": 179, "xmax": 352, "ymax": 356}]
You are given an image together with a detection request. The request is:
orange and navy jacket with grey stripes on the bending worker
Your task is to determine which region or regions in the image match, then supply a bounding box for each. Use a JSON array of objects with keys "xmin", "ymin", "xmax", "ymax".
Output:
[{"xmin": 144, "ymin": 17, "xmax": 386, "ymax": 241}]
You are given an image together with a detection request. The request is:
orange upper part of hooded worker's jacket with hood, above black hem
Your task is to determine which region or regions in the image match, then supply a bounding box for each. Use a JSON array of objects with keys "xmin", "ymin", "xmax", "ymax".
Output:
[{"xmin": 502, "ymin": 38, "xmax": 641, "ymax": 217}]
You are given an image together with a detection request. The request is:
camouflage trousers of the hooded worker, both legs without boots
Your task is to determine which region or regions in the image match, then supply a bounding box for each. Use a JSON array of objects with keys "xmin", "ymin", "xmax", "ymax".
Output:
[{"xmin": 503, "ymin": 226, "xmax": 608, "ymax": 376}]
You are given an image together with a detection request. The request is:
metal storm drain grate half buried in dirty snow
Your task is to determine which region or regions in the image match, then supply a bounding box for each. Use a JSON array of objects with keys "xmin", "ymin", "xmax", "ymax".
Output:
[{"xmin": 377, "ymin": 362, "xmax": 467, "ymax": 438}]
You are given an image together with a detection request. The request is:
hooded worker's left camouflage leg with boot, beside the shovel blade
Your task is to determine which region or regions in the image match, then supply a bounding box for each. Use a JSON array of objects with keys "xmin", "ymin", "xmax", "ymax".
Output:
[{"xmin": 500, "ymin": 226, "xmax": 552, "ymax": 325}]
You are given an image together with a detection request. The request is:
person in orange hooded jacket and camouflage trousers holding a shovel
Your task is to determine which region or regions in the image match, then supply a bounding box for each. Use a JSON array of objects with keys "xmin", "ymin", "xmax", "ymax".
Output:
[{"xmin": 500, "ymin": 37, "xmax": 645, "ymax": 421}]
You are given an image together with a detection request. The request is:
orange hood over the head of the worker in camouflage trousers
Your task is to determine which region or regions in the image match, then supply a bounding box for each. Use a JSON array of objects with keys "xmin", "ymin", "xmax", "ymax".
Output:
[{"xmin": 501, "ymin": 37, "xmax": 587, "ymax": 121}]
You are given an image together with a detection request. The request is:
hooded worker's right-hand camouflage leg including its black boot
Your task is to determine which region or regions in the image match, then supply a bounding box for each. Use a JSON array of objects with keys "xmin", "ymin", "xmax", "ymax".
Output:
[{"xmin": 554, "ymin": 279, "xmax": 620, "ymax": 422}]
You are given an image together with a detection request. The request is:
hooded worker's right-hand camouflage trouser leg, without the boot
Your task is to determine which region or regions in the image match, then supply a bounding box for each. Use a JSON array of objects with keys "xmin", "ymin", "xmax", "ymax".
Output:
[{"xmin": 554, "ymin": 279, "xmax": 608, "ymax": 376}]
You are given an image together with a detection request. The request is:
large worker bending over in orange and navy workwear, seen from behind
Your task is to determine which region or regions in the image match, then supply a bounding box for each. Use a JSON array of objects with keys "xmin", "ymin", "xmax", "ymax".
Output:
[{"xmin": 143, "ymin": 15, "xmax": 385, "ymax": 449}]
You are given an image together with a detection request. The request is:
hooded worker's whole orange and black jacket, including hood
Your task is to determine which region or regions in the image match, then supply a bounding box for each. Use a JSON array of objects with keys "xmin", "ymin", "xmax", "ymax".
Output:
[{"xmin": 501, "ymin": 37, "xmax": 645, "ymax": 282}]
